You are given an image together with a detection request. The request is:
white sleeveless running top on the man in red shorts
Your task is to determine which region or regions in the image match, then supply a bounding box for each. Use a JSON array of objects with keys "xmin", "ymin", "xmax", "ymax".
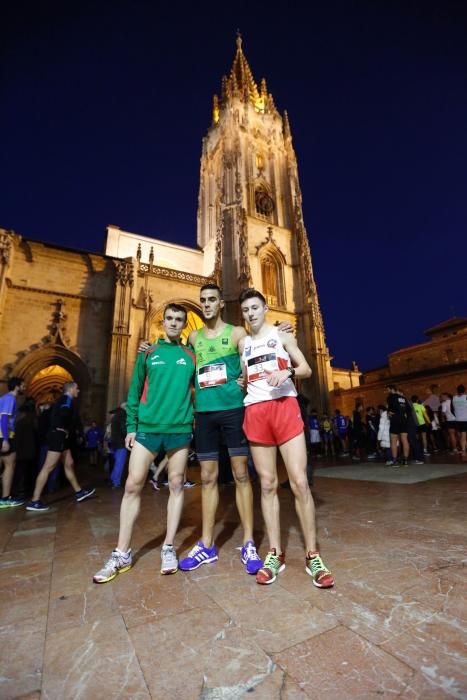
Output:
[{"xmin": 242, "ymin": 326, "xmax": 297, "ymax": 406}]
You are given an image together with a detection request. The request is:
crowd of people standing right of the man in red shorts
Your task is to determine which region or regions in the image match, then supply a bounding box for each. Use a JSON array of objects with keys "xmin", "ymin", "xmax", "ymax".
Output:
[{"xmin": 308, "ymin": 384, "xmax": 467, "ymax": 468}]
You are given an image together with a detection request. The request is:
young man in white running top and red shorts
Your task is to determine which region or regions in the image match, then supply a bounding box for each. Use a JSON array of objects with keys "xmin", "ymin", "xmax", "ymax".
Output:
[{"xmin": 238, "ymin": 289, "xmax": 334, "ymax": 588}]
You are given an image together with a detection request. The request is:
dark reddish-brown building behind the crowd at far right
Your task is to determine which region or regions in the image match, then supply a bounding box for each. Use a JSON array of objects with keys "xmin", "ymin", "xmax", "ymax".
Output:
[{"xmin": 332, "ymin": 318, "xmax": 467, "ymax": 415}]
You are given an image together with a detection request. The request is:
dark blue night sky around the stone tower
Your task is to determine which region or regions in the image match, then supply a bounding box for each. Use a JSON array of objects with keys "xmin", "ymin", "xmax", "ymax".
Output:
[{"xmin": 0, "ymin": 0, "xmax": 467, "ymax": 369}]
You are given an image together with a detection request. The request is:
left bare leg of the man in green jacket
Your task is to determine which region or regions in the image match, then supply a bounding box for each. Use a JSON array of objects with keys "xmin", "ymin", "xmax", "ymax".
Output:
[{"xmin": 117, "ymin": 442, "xmax": 157, "ymax": 552}]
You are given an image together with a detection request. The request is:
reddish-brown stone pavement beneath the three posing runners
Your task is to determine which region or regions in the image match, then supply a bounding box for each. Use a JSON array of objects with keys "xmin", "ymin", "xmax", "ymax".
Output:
[{"xmin": 0, "ymin": 460, "xmax": 467, "ymax": 700}]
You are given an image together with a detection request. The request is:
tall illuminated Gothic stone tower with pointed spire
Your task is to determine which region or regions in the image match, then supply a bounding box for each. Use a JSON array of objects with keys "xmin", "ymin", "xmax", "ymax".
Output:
[{"xmin": 198, "ymin": 36, "xmax": 332, "ymax": 411}]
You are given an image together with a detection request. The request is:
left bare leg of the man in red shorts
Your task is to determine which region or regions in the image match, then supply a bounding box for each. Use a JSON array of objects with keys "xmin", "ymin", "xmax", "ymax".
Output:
[{"xmin": 250, "ymin": 443, "xmax": 282, "ymax": 553}]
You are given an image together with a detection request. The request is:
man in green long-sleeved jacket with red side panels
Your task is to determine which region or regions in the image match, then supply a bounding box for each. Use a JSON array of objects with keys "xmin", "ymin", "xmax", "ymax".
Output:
[{"xmin": 94, "ymin": 304, "xmax": 195, "ymax": 583}]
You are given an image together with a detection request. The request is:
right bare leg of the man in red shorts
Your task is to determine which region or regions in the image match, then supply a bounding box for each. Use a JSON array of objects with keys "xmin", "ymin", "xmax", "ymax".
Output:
[{"xmin": 279, "ymin": 433, "xmax": 316, "ymax": 552}]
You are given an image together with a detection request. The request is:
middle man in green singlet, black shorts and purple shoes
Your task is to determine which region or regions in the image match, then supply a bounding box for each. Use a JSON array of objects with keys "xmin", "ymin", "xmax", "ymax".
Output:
[{"xmin": 179, "ymin": 284, "xmax": 262, "ymax": 574}]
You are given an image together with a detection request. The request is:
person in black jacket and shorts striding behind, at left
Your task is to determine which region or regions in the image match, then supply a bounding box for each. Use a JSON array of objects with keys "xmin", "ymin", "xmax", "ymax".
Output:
[{"xmin": 26, "ymin": 382, "xmax": 96, "ymax": 512}]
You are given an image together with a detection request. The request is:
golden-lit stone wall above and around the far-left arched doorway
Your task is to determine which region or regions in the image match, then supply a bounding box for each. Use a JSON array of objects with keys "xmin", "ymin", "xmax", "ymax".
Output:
[{"xmin": 0, "ymin": 234, "xmax": 115, "ymax": 418}]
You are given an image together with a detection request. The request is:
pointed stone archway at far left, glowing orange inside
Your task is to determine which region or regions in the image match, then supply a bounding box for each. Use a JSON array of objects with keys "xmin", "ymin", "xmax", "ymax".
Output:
[{"xmin": 11, "ymin": 344, "xmax": 91, "ymax": 408}]
